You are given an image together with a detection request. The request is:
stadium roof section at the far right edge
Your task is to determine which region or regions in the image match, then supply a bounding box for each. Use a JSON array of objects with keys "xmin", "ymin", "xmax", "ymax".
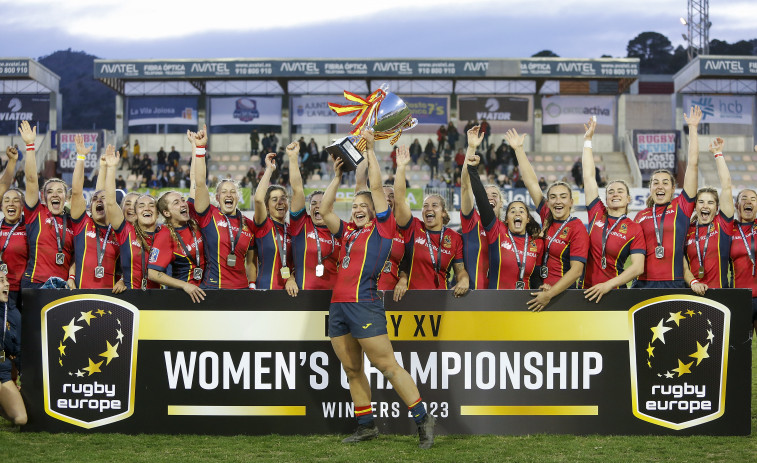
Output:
[{"xmin": 673, "ymin": 55, "xmax": 757, "ymax": 94}]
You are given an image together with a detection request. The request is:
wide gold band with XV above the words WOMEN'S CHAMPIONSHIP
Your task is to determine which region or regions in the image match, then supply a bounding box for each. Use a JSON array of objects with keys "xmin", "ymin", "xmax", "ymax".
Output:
[{"xmin": 139, "ymin": 310, "xmax": 630, "ymax": 341}]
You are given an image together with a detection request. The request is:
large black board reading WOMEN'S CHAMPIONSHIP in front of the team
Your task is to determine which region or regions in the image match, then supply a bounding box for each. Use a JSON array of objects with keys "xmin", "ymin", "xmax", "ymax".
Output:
[{"xmin": 23, "ymin": 289, "xmax": 751, "ymax": 435}]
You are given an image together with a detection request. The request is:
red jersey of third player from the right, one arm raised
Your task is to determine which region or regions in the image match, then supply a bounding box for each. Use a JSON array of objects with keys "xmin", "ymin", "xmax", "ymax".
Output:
[{"xmin": 633, "ymin": 191, "xmax": 695, "ymax": 281}]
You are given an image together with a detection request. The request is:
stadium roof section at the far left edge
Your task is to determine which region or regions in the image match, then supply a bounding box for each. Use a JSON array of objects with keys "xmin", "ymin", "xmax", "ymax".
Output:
[{"xmin": 0, "ymin": 58, "xmax": 60, "ymax": 94}]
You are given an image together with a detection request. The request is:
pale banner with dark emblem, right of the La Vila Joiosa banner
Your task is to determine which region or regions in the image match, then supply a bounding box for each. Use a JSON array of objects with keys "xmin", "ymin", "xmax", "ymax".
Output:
[{"xmin": 210, "ymin": 96, "xmax": 281, "ymax": 126}]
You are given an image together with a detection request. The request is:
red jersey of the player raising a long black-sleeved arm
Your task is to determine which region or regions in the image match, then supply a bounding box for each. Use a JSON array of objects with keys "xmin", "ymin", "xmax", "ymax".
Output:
[{"xmin": 486, "ymin": 220, "xmax": 544, "ymax": 289}]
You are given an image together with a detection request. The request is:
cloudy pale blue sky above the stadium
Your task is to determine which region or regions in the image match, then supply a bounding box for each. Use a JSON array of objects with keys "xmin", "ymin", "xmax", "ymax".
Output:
[{"xmin": 0, "ymin": 0, "xmax": 757, "ymax": 59}]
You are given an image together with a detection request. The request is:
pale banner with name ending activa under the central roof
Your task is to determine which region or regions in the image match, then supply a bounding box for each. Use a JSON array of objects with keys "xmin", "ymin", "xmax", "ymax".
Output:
[{"xmin": 541, "ymin": 96, "xmax": 615, "ymax": 125}]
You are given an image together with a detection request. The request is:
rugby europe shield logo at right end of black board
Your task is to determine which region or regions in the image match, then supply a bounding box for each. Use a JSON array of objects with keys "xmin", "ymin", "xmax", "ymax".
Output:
[{"xmin": 628, "ymin": 294, "xmax": 731, "ymax": 430}]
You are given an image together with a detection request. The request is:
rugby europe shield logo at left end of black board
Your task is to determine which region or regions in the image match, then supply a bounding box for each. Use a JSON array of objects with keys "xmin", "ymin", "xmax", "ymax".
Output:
[{"xmin": 42, "ymin": 294, "xmax": 139, "ymax": 429}]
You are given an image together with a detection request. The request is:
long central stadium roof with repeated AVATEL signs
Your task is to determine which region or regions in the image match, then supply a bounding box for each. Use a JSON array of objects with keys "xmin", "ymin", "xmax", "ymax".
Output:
[{"xmin": 94, "ymin": 58, "xmax": 639, "ymax": 95}]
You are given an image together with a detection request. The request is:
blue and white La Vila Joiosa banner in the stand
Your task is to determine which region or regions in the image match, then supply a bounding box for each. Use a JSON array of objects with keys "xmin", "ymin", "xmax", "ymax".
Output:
[{"xmin": 129, "ymin": 96, "xmax": 197, "ymax": 127}]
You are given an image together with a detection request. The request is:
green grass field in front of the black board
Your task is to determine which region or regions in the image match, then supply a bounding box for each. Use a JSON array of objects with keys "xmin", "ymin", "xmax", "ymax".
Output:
[{"xmin": 0, "ymin": 343, "xmax": 757, "ymax": 463}]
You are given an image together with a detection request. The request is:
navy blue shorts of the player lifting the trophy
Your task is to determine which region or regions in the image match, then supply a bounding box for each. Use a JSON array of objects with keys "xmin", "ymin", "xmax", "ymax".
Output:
[{"xmin": 329, "ymin": 300, "xmax": 388, "ymax": 338}]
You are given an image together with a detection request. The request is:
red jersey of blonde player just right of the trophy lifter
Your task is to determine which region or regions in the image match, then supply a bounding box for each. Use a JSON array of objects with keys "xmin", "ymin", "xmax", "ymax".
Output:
[{"xmin": 400, "ymin": 217, "xmax": 463, "ymax": 289}]
